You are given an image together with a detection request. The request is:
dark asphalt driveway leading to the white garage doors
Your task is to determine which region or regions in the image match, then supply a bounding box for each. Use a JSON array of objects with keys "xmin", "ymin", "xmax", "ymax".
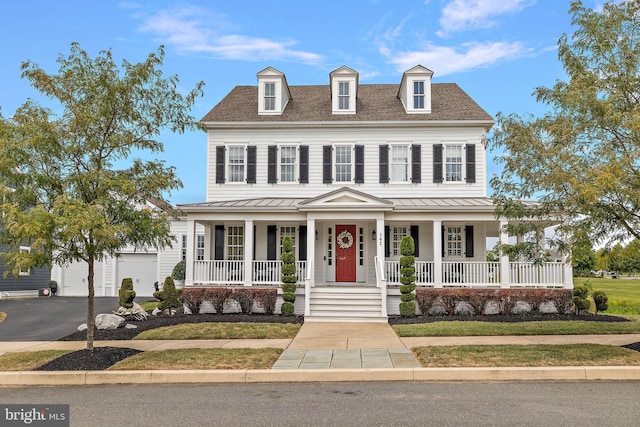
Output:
[{"xmin": 0, "ymin": 297, "xmax": 118, "ymax": 341}]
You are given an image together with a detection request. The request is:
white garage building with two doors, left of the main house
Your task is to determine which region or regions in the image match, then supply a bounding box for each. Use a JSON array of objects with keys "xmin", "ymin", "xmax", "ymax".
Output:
[{"xmin": 51, "ymin": 201, "xmax": 202, "ymax": 297}]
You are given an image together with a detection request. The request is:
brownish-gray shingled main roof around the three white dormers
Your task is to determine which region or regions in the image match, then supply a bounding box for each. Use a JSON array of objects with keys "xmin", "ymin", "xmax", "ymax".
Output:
[{"xmin": 202, "ymin": 83, "xmax": 493, "ymax": 123}]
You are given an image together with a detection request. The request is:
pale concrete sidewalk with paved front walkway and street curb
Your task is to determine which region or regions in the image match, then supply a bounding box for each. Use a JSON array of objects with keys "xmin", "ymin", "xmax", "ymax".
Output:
[{"xmin": 0, "ymin": 322, "xmax": 640, "ymax": 386}]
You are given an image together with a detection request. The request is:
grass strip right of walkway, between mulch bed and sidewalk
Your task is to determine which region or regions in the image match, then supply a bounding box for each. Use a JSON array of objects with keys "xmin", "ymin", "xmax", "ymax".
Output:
[{"xmin": 393, "ymin": 320, "xmax": 640, "ymax": 337}]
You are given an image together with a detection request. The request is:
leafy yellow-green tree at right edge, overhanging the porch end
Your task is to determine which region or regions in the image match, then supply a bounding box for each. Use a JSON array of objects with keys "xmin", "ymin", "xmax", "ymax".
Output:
[{"xmin": 490, "ymin": 0, "xmax": 640, "ymax": 249}]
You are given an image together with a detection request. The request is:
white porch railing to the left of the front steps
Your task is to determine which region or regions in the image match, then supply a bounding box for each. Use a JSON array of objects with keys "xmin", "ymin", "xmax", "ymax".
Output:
[{"xmin": 193, "ymin": 260, "xmax": 307, "ymax": 286}]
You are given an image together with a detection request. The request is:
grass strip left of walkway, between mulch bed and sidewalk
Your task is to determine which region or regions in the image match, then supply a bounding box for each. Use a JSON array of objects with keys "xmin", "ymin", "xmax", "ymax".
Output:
[{"xmin": 134, "ymin": 322, "xmax": 300, "ymax": 340}]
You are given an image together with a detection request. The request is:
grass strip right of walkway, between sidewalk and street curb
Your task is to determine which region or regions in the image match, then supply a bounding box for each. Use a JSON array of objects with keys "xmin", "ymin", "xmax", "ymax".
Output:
[{"xmin": 411, "ymin": 344, "xmax": 640, "ymax": 368}]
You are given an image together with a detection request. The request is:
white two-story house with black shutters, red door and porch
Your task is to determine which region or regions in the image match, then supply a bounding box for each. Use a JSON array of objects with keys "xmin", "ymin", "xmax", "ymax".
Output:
[{"xmin": 179, "ymin": 65, "xmax": 571, "ymax": 321}]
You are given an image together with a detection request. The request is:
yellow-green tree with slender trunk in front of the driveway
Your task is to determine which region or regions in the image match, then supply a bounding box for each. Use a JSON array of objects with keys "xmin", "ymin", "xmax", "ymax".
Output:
[{"xmin": 0, "ymin": 43, "xmax": 203, "ymax": 350}]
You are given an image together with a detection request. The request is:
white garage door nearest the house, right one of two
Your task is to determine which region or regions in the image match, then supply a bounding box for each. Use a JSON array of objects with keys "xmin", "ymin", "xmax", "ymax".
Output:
[{"xmin": 116, "ymin": 254, "xmax": 158, "ymax": 296}]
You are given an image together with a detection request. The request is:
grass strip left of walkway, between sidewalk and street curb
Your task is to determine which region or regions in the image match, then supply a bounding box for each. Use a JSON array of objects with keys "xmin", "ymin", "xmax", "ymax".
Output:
[{"xmin": 109, "ymin": 348, "xmax": 283, "ymax": 370}]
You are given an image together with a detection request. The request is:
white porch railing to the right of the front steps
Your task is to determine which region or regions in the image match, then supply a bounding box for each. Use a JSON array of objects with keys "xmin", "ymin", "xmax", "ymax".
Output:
[{"xmin": 383, "ymin": 261, "xmax": 564, "ymax": 287}]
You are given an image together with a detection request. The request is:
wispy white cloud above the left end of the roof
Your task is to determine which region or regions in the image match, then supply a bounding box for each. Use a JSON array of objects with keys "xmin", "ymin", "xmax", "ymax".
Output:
[{"xmin": 140, "ymin": 8, "xmax": 322, "ymax": 64}]
